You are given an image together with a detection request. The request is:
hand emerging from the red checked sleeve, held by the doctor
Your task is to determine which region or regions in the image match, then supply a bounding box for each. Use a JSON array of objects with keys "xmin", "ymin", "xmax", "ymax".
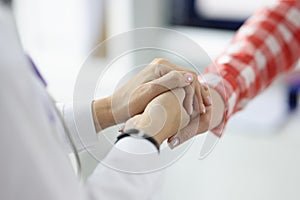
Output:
[{"xmin": 168, "ymin": 85, "xmax": 225, "ymax": 149}]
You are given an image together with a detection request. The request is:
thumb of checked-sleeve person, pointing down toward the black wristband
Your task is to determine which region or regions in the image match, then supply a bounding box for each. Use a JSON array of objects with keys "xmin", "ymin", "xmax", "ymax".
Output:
[{"xmin": 168, "ymin": 117, "xmax": 199, "ymax": 149}]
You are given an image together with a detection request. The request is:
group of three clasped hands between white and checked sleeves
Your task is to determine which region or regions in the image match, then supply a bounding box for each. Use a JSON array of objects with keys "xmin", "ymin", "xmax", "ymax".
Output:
[{"xmin": 93, "ymin": 58, "xmax": 222, "ymax": 148}]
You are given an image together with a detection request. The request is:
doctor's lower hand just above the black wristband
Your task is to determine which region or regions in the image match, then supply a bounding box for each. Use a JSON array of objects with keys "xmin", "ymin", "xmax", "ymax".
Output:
[{"xmin": 124, "ymin": 88, "xmax": 190, "ymax": 145}]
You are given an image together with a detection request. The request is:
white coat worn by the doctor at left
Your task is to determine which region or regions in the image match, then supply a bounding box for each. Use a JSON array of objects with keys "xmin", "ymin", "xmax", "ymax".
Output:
[{"xmin": 0, "ymin": 5, "xmax": 161, "ymax": 200}]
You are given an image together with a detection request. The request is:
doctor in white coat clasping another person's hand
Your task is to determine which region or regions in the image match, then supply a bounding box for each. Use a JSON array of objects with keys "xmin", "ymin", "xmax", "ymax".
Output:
[{"xmin": 0, "ymin": 0, "xmax": 210, "ymax": 200}]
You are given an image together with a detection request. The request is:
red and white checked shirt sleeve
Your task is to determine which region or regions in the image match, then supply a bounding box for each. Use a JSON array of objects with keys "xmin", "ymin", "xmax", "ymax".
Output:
[{"xmin": 202, "ymin": 1, "xmax": 300, "ymax": 136}]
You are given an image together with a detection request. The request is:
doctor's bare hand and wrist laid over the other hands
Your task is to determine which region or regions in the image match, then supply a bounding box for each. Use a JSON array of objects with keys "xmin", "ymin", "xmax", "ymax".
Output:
[{"xmin": 93, "ymin": 59, "xmax": 209, "ymax": 131}]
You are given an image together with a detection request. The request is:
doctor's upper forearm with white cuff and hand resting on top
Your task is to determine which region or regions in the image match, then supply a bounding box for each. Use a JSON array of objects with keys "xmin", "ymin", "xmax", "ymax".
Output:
[{"xmin": 59, "ymin": 59, "xmax": 202, "ymax": 151}]
